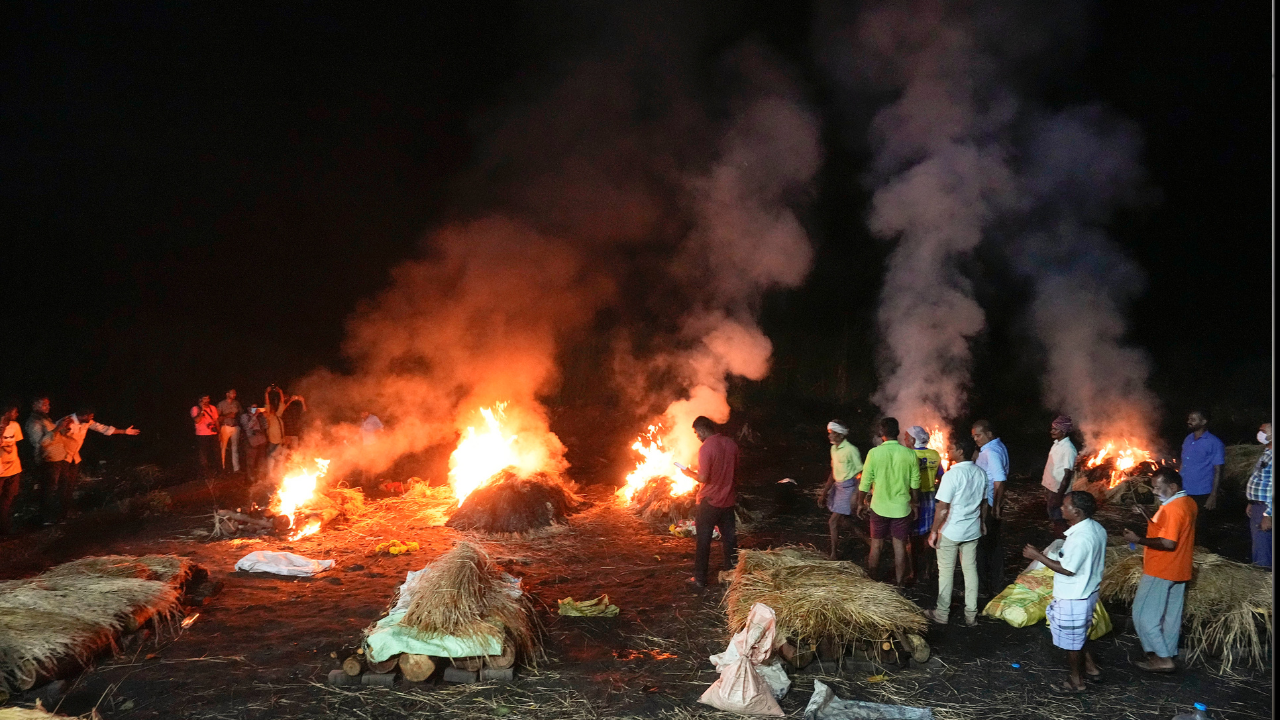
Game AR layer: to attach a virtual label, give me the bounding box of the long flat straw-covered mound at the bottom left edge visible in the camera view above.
[0,555,192,692]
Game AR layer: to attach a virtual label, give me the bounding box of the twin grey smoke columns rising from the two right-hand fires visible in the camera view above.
[824,0,1157,447]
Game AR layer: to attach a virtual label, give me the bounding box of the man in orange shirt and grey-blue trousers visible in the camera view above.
[1124,468,1199,673]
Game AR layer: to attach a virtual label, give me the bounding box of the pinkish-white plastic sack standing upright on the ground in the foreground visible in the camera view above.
[698,602,782,717]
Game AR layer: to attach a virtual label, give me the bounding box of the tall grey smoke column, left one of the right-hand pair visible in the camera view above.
[835,1,1016,427]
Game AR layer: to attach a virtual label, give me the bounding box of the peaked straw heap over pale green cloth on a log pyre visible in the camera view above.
[401,542,538,660]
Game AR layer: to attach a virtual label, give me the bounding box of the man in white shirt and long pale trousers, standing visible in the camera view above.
[924,437,987,628]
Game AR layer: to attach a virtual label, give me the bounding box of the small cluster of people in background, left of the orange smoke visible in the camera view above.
[191,384,307,480]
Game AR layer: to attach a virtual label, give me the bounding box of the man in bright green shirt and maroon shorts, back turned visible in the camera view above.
[854,418,920,587]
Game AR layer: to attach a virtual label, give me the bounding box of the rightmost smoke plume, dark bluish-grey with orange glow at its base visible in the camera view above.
[1011,106,1160,450]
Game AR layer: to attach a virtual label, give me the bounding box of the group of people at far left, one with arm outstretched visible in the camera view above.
[0,397,138,536]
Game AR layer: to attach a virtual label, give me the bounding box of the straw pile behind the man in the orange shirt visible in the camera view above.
[1100,544,1272,673]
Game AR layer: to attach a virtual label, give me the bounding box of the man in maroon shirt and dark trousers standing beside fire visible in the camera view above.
[686,415,737,588]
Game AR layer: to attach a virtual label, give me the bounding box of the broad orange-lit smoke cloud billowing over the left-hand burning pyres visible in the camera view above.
[296,22,820,481]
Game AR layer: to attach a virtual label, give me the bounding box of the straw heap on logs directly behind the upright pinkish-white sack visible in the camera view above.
[724,547,928,647]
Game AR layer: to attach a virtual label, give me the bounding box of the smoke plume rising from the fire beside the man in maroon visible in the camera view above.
[663,53,822,461]
